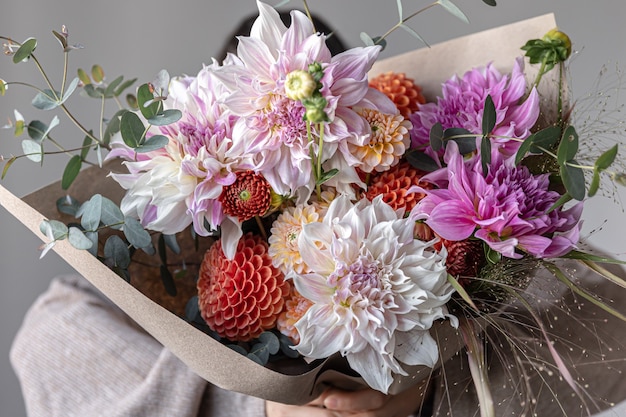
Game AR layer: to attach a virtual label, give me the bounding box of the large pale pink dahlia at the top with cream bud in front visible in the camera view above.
[216,2,397,201]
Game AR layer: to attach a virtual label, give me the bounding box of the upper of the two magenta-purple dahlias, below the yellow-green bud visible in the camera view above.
[411,58,539,160]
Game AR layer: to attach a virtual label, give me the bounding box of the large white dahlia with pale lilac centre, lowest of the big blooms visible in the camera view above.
[294,196,453,393]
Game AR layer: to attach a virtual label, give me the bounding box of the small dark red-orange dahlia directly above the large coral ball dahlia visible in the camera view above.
[219,170,272,222]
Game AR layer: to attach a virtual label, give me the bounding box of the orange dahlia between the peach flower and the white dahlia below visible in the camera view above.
[365,161,432,213]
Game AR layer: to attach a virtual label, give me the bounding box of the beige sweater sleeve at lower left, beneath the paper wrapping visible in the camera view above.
[11,276,264,417]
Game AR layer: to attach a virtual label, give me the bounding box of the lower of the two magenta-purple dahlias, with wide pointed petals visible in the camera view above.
[411,142,583,258]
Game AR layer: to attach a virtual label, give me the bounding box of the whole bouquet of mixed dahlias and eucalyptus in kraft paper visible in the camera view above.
[0,0,626,415]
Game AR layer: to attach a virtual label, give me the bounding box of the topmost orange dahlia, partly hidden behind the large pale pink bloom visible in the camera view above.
[370,72,426,118]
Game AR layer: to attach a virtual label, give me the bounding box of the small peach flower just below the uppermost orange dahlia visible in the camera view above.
[349,109,411,172]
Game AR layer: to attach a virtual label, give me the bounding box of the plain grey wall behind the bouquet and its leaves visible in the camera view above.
[0,0,626,417]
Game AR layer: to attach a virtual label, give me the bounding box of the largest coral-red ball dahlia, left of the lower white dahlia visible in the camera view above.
[198,233,290,342]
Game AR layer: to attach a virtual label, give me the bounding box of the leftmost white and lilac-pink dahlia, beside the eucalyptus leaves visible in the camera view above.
[108,64,254,256]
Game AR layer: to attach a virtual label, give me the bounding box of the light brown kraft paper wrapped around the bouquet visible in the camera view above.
[0,14,556,404]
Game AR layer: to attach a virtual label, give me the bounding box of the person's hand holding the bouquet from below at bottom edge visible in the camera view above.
[266,381,427,417]
